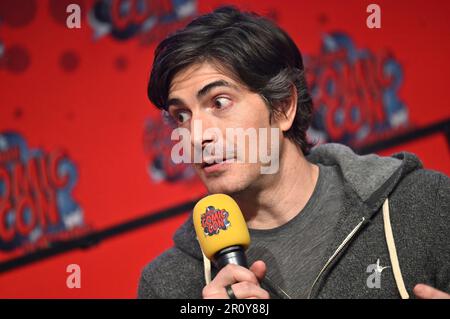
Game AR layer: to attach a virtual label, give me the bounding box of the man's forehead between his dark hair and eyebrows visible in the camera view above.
[169,62,242,98]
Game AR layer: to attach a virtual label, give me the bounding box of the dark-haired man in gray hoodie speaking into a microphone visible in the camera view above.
[138,7,450,298]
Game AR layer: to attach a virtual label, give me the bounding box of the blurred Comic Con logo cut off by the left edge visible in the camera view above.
[0,132,83,251]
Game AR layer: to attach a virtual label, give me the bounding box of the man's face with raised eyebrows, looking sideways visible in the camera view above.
[168,62,279,194]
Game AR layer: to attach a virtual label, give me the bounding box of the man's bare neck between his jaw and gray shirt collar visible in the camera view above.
[233,140,319,229]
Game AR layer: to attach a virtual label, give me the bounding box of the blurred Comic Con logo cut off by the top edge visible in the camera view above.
[88,0,197,43]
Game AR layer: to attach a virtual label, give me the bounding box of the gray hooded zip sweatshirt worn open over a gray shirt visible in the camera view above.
[138,144,450,298]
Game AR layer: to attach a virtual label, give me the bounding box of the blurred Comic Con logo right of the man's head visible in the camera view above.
[305,33,408,145]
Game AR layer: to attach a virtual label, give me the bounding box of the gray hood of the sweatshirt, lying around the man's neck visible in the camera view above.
[173,143,422,260]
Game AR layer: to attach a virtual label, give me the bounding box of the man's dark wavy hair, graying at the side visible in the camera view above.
[148,6,313,155]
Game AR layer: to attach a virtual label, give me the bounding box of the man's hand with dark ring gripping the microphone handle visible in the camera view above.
[202,260,270,299]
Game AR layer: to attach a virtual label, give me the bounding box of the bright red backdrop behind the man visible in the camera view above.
[0,0,450,298]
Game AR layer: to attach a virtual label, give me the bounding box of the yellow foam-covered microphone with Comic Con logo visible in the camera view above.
[192,194,250,269]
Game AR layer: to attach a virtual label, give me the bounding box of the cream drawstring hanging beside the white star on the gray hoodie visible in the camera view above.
[383,198,409,299]
